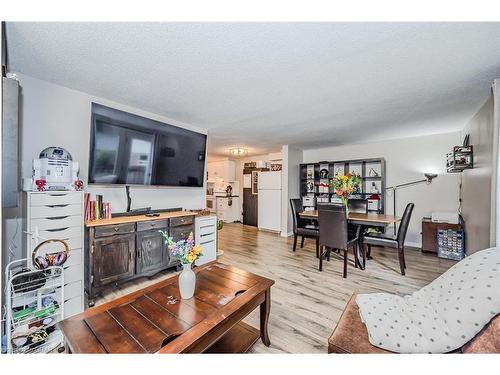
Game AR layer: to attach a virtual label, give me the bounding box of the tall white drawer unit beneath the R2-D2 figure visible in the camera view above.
[23,191,84,318]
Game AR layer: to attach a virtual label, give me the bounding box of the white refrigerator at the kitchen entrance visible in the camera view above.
[257,172,281,232]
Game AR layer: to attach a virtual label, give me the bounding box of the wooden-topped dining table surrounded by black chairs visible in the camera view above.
[299,210,401,269]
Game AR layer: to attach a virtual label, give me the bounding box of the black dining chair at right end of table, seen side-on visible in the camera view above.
[363,203,415,275]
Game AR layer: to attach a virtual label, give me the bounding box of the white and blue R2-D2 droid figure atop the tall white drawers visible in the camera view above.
[24,147,83,191]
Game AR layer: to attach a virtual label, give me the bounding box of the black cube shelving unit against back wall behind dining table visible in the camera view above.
[299,158,386,214]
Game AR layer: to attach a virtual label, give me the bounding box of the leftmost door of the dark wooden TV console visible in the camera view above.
[92,234,135,286]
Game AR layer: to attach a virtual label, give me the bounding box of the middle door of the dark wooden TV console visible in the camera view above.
[136,230,169,275]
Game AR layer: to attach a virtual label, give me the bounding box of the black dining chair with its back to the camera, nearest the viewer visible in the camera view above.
[318,203,361,278]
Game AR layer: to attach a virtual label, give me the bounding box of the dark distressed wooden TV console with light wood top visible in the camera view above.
[85,213,195,306]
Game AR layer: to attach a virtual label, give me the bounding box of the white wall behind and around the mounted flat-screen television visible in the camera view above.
[3,74,206,262]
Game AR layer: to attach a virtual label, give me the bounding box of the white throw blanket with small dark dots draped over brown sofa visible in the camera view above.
[356,247,500,353]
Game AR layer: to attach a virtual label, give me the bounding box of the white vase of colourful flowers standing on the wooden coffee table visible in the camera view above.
[159,230,203,299]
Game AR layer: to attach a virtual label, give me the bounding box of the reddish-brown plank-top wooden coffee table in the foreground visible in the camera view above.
[59,263,274,353]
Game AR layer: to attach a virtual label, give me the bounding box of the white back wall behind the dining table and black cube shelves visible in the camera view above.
[303,132,461,247]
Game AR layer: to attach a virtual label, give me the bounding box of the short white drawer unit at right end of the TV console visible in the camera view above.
[194,215,217,266]
